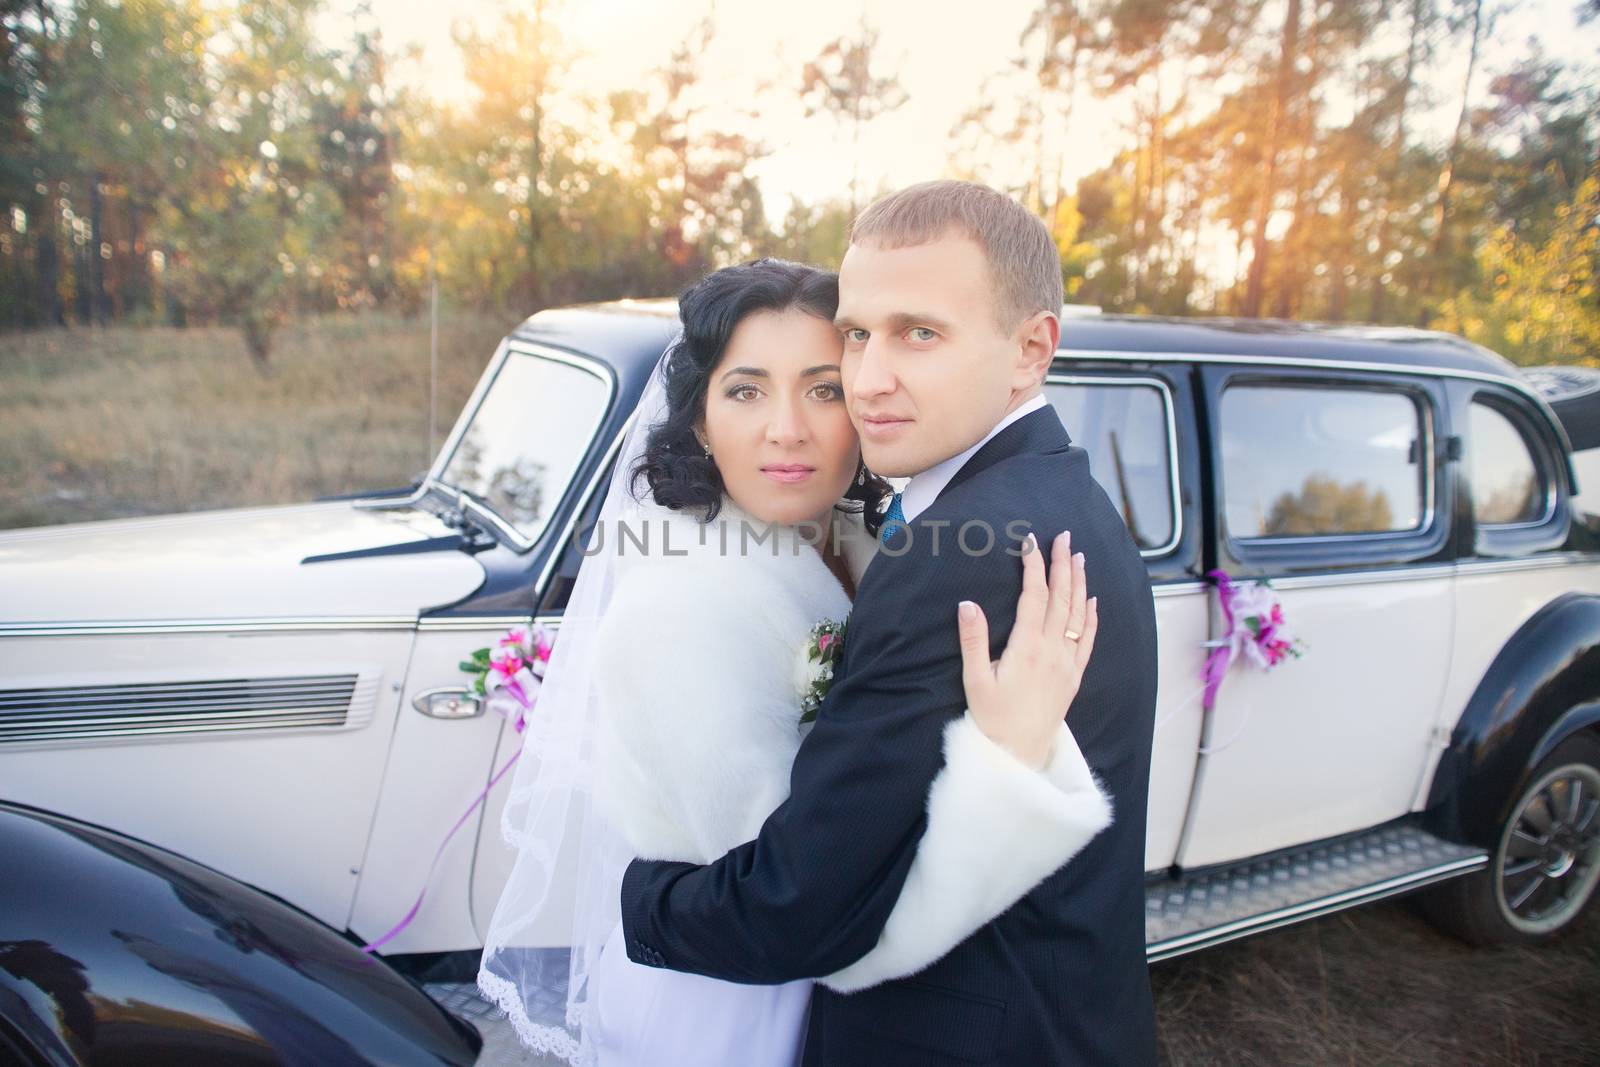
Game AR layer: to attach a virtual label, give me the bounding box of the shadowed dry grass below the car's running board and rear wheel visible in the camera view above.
[1150,901,1600,1067]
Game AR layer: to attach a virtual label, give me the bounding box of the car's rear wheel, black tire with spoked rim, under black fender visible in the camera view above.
[1418,733,1600,945]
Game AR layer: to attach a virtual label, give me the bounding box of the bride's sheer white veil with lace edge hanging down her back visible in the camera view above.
[478,330,683,1064]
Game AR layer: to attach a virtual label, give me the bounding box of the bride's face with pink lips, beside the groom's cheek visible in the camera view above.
[701,309,861,525]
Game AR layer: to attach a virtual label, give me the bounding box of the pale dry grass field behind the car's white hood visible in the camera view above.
[0,315,514,530]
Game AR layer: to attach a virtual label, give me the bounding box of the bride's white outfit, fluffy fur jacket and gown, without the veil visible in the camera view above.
[587,502,1112,1067]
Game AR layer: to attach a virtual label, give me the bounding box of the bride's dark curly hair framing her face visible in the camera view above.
[632,259,891,534]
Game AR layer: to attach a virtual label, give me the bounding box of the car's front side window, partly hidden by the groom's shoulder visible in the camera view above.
[1045,381,1176,553]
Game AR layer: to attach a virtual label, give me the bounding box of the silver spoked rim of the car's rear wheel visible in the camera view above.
[1498,763,1600,933]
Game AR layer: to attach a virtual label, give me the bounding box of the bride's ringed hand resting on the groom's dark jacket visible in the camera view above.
[957,531,1099,768]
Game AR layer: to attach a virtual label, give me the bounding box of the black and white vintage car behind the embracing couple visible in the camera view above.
[0,301,1600,1062]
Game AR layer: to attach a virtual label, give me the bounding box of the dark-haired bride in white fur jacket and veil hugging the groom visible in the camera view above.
[478,259,1112,1067]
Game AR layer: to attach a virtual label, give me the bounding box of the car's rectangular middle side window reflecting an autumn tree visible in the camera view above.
[1219,386,1429,537]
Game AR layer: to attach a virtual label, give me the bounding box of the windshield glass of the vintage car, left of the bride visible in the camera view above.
[438,349,611,544]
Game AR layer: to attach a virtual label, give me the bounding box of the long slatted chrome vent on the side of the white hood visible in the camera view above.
[0,672,366,744]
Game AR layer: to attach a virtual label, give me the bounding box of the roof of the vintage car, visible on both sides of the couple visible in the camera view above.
[512,299,1526,389]
